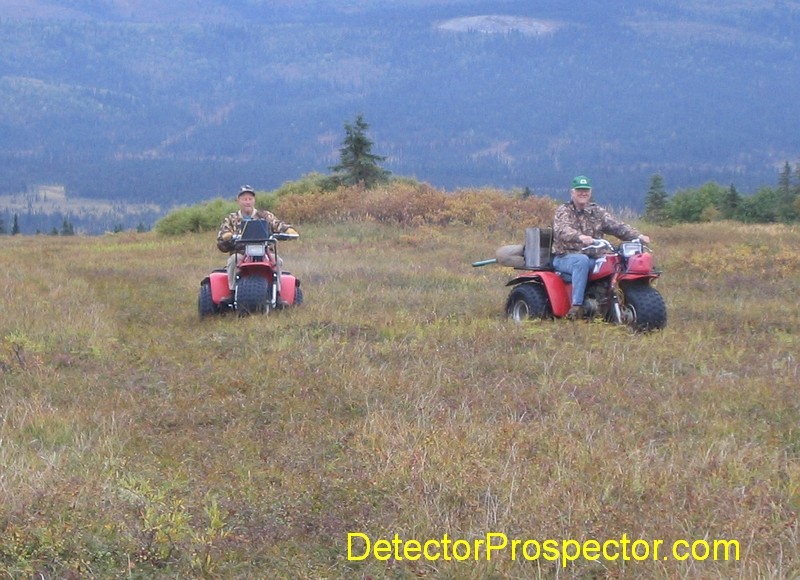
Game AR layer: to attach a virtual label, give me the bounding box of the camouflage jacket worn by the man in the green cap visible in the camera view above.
[553,201,639,256]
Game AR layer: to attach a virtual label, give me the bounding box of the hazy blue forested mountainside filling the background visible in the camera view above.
[0,0,800,231]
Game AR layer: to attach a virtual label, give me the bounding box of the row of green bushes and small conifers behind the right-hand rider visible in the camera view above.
[643,161,800,224]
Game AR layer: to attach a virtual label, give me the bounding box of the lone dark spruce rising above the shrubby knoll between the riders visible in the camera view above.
[330,114,390,189]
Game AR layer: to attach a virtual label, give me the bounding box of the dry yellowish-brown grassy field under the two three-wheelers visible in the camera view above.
[0,223,800,578]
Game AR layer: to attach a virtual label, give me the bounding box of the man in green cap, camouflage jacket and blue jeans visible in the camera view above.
[553,175,650,320]
